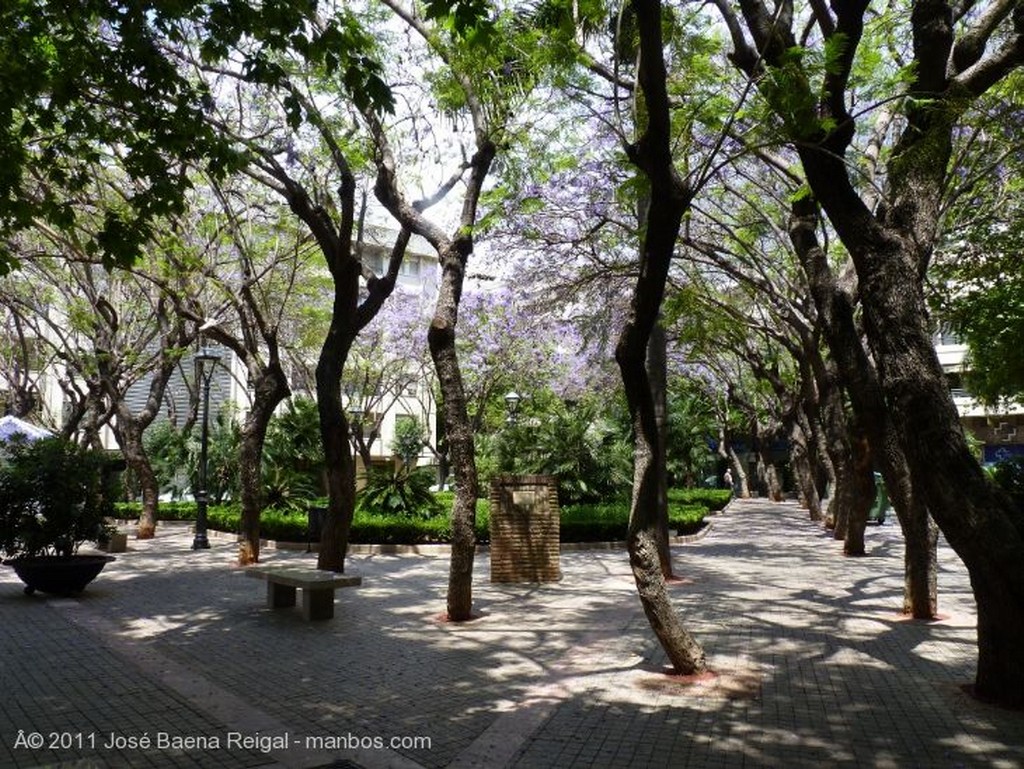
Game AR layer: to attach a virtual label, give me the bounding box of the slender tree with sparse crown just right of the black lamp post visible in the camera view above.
[154,177,312,565]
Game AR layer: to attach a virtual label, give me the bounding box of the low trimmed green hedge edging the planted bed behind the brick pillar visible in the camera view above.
[118,489,712,545]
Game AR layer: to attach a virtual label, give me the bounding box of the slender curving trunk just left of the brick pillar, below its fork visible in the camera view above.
[427,242,477,622]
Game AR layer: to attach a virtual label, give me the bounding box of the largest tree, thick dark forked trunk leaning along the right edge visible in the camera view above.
[716,0,1024,704]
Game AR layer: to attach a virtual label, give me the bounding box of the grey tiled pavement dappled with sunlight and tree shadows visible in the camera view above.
[0,501,1024,769]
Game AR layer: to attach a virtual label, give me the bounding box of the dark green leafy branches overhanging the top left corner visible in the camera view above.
[0,0,394,274]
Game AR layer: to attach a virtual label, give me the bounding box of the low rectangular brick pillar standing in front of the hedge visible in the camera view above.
[490,475,562,583]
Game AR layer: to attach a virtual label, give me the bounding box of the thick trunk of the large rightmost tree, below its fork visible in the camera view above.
[864,264,1024,707]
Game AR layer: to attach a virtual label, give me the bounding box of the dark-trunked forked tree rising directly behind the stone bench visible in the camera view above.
[172,3,419,571]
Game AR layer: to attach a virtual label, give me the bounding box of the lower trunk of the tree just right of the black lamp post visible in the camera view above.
[239,361,291,566]
